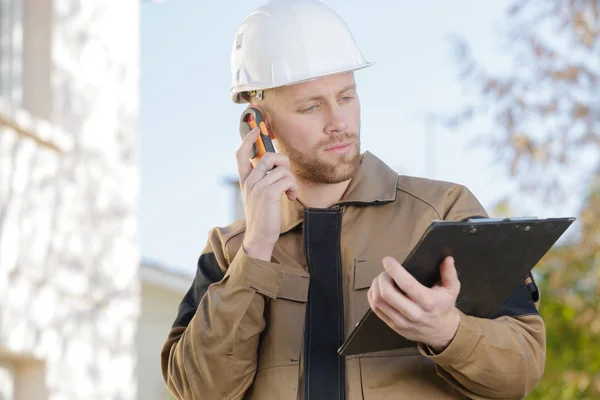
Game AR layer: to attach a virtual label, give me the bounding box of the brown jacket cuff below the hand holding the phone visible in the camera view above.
[225,246,285,299]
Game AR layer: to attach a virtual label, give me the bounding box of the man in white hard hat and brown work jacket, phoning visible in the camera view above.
[161,0,545,400]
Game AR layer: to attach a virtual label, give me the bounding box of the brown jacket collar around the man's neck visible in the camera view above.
[281,151,398,234]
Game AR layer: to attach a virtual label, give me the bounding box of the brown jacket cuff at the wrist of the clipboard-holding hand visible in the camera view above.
[419,310,481,365]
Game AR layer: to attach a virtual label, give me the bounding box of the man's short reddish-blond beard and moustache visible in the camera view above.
[277,132,360,184]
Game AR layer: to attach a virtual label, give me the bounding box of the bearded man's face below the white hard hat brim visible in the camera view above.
[265,72,360,184]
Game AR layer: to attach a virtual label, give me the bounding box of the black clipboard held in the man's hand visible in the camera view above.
[338,217,575,356]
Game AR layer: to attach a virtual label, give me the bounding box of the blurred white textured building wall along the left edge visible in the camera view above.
[0,0,141,400]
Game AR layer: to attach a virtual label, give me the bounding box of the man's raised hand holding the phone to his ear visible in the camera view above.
[236,128,298,262]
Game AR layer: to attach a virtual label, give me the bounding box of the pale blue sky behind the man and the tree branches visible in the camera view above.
[140,0,580,272]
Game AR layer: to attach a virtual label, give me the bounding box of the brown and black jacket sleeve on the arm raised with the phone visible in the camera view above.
[161,230,283,400]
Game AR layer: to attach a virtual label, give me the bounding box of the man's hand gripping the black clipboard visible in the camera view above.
[368,257,460,353]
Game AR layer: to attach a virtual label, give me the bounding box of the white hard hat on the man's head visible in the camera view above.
[230,0,372,103]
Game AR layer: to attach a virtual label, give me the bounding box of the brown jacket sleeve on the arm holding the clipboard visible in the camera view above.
[419,186,546,399]
